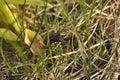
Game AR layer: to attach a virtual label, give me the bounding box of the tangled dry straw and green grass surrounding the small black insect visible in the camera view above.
[0,0,120,80]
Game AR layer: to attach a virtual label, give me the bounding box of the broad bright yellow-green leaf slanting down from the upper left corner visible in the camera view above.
[0,0,21,34]
